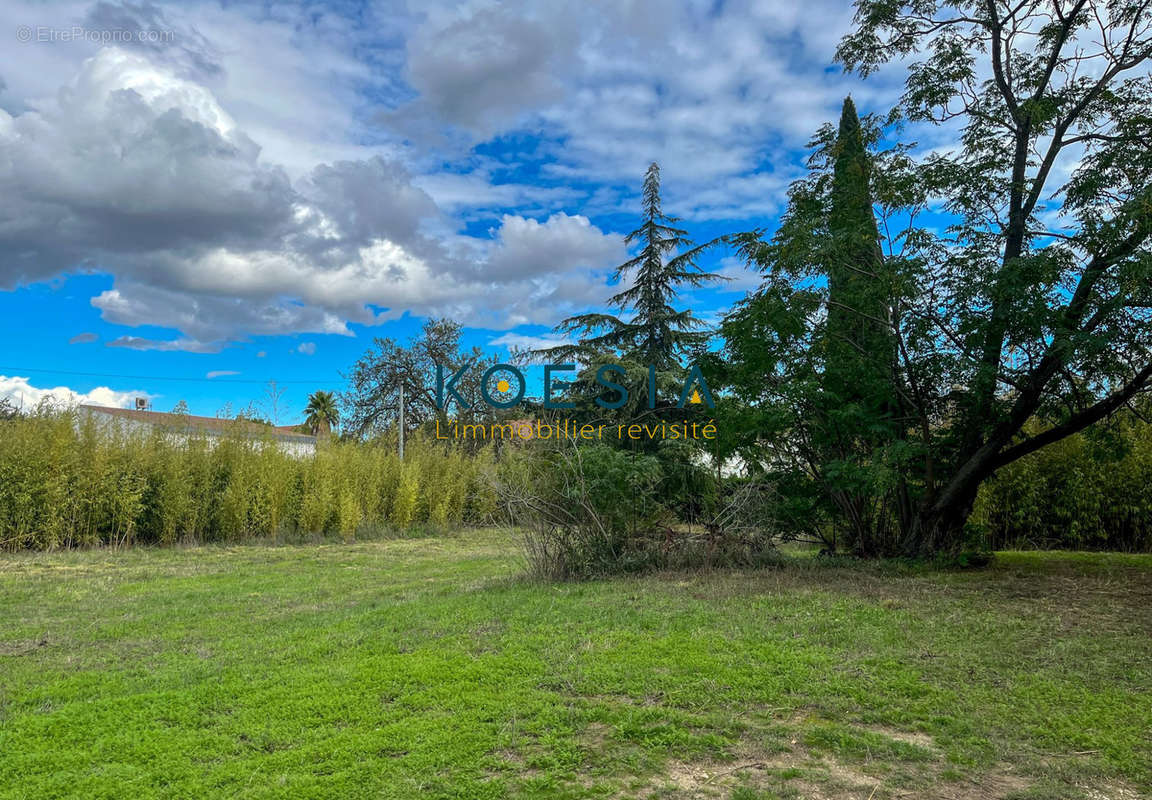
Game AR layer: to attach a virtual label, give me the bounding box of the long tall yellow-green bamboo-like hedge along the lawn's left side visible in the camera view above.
[0,409,494,550]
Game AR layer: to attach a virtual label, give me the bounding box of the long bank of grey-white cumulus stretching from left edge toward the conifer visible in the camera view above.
[0,47,623,341]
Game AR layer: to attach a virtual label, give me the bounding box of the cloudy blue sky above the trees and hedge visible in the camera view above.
[0,0,900,424]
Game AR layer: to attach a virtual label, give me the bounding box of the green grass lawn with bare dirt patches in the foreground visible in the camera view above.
[0,531,1152,800]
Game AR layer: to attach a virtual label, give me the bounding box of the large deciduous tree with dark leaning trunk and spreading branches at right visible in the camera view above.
[728,0,1152,554]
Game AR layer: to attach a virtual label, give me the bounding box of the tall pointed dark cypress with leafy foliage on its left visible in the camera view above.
[706,99,922,556]
